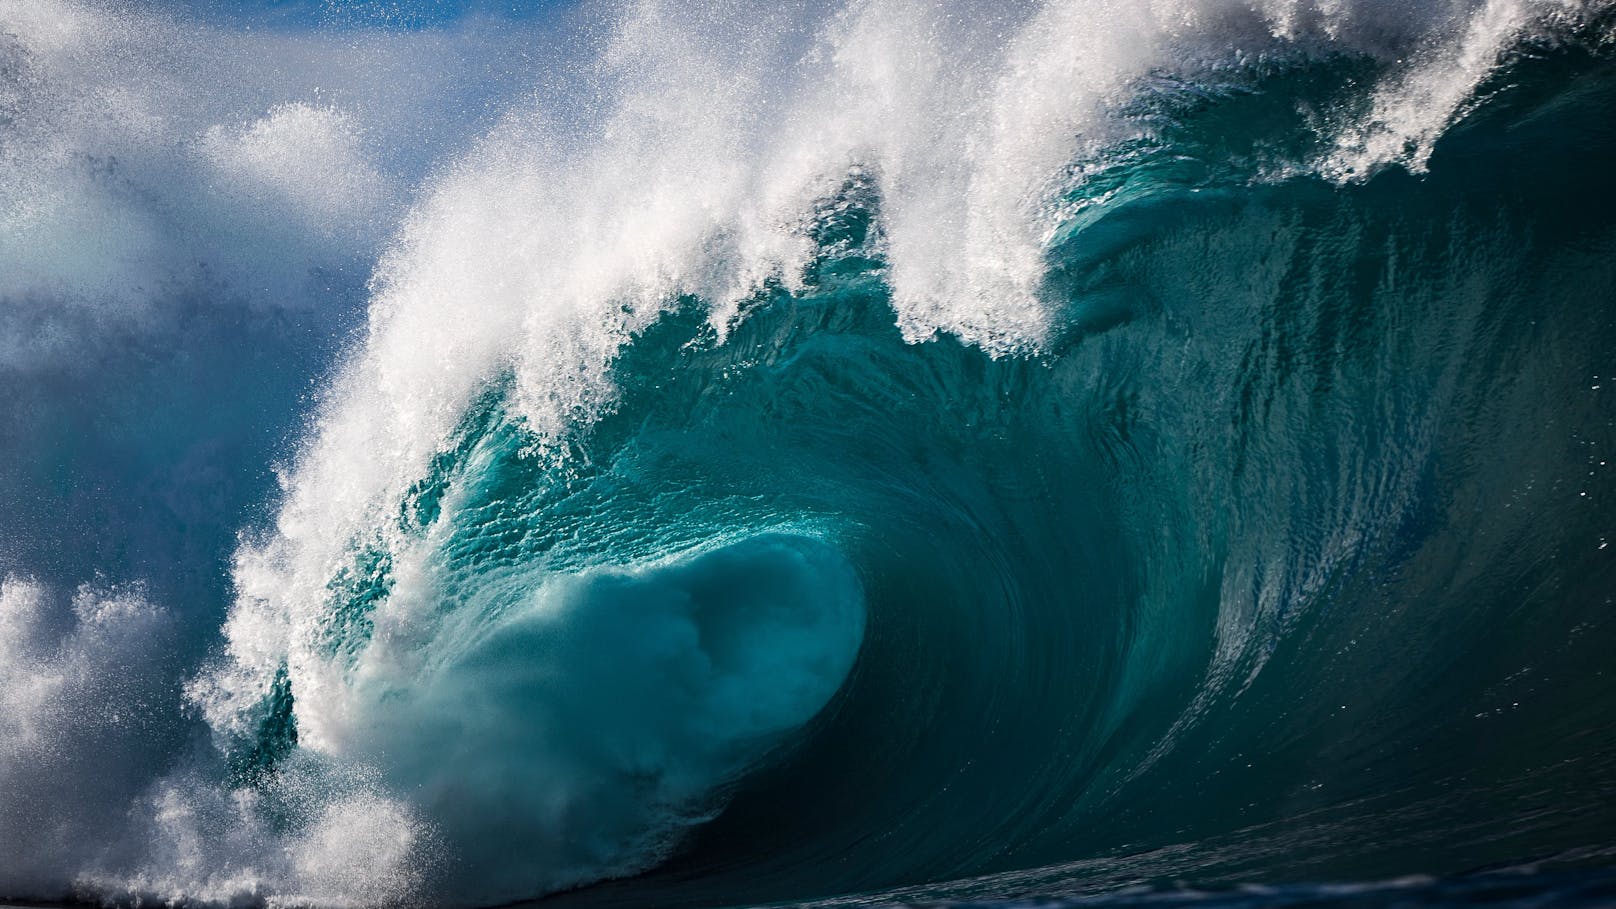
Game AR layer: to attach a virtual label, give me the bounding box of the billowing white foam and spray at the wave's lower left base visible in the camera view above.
[0,576,431,906]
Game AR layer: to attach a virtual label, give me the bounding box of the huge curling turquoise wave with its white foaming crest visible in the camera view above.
[0,5,1616,906]
